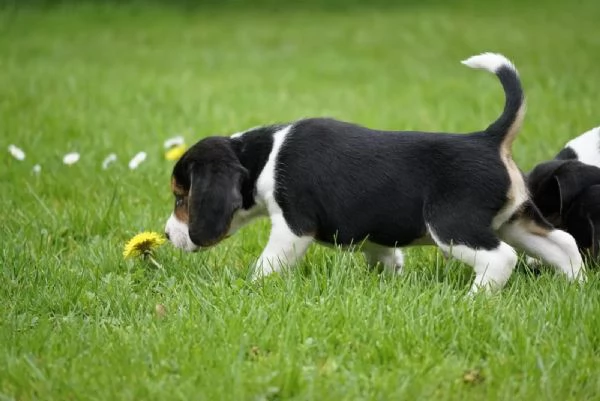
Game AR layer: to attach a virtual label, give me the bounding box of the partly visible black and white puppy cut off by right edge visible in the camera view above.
[527,128,600,261]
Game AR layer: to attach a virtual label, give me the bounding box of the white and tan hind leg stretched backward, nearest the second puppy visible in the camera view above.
[498,202,585,281]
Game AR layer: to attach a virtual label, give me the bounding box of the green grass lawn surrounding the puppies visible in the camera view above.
[0,0,600,401]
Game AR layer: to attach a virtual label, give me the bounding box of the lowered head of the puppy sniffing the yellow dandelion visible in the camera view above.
[165,137,246,252]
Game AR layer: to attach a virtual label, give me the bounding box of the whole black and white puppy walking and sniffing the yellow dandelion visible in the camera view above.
[166,53,583,291]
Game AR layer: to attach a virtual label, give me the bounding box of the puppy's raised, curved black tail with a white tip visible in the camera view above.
[462,53,526,149]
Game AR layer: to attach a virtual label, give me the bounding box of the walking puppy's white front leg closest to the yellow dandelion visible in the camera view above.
[253,214,313,280]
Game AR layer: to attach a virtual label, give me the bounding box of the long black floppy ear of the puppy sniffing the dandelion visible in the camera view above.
[188,161,247,247]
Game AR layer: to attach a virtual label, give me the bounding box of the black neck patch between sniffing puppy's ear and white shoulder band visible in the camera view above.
[231,125,281,210]
